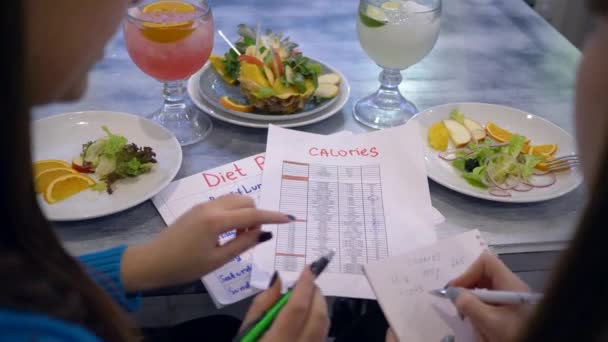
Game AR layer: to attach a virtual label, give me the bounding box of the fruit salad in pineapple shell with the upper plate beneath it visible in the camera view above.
[198,22,344,122]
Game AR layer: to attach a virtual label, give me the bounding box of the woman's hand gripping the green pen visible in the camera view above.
[241,267,329,342]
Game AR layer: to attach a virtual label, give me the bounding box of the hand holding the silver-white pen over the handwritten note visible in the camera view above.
[449,252,532,342]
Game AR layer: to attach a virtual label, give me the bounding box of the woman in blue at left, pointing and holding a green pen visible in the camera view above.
[0,0,328,341]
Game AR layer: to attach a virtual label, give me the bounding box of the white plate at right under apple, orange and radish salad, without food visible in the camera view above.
[411,103,582,203]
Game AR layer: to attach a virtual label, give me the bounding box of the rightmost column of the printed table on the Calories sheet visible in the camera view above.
[361,165,388,261]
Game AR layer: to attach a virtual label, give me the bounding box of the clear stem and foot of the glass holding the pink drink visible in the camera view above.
[150,80,213,146]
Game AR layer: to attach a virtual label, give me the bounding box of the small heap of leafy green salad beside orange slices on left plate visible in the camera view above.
[72,126,157,194]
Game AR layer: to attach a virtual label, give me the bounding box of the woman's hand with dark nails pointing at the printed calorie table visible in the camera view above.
[121,195,290,292]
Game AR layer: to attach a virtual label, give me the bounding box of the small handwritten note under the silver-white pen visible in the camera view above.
[364,230,487,342]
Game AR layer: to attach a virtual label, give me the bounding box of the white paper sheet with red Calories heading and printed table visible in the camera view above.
[251,123,437,298]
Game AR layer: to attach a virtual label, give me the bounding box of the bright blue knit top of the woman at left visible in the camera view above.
[0,245,141,342]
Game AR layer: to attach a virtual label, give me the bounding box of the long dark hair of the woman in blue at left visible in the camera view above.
[0,1,135,341]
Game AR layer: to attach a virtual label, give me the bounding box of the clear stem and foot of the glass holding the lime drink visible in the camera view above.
[354,69,418,129]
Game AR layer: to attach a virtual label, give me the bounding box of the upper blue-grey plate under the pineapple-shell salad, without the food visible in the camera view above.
[198,59,338,122]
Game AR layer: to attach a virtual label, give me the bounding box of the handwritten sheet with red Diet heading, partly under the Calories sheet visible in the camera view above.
[152,154,265,306]
